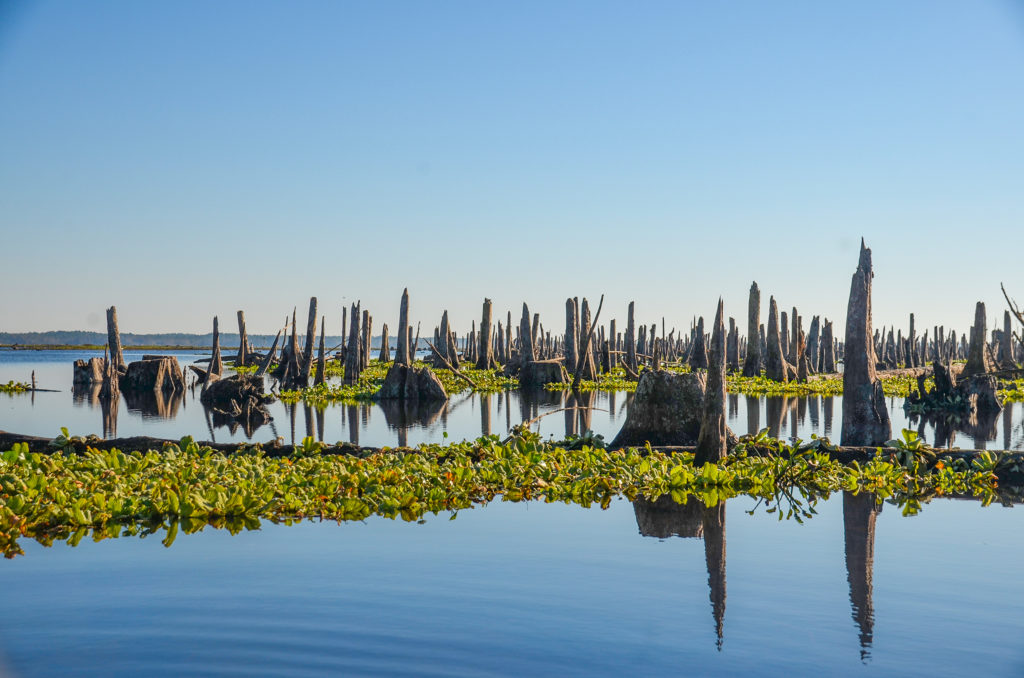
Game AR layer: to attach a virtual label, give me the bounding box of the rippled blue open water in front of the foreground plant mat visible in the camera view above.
[0,495,1024,678]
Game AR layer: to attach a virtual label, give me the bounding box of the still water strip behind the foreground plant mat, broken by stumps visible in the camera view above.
[0,350,1024,450]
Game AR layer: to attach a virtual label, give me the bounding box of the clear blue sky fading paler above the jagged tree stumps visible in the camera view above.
[0,0,1024,336]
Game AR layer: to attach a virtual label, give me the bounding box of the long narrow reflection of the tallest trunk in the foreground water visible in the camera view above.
[843,492,882,660]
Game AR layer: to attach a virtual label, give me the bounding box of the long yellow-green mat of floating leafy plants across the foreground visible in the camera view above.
[0,431,1007,557]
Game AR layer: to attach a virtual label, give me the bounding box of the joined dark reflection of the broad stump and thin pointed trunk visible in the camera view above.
[633,495,725,650]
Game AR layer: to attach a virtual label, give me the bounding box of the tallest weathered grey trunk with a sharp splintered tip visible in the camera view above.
[841,240,892,446]
